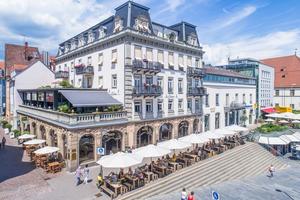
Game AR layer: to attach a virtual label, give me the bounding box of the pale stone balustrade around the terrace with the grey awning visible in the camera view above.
[18,105,127,125]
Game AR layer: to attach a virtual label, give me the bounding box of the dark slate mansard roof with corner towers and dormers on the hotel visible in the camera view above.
[59,1,199,54]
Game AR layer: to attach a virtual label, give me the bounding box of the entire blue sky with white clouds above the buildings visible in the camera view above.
[0,0,300,64]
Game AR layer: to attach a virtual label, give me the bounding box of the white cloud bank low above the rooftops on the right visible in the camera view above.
[203,29,300,65]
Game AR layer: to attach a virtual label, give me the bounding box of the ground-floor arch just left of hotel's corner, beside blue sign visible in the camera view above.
[102,131,122,155]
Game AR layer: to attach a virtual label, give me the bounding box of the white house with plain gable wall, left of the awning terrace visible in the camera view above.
[7,61,55,128]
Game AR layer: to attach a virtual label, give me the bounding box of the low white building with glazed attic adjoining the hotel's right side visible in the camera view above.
[203,67,256,131]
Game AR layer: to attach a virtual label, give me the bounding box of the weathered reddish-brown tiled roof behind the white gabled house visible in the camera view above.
[5,44,41,74]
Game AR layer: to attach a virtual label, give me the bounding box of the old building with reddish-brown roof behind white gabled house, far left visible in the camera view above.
[4,42,41,120]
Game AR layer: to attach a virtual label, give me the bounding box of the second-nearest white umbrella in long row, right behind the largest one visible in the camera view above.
[133,144,171,158]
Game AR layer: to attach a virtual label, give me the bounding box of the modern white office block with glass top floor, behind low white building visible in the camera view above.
[218,58,275,117]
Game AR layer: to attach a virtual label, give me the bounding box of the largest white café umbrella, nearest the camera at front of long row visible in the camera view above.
[97,152,143,169]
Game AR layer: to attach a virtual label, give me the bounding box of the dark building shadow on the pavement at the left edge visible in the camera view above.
[0,145,35,183]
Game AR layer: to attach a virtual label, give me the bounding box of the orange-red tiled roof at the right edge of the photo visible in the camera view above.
[261,55,300,88]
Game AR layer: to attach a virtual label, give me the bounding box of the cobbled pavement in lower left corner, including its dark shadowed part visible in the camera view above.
[0,128,108,200]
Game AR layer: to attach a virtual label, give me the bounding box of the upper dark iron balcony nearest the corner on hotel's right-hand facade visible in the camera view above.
[132,59,163,74]
